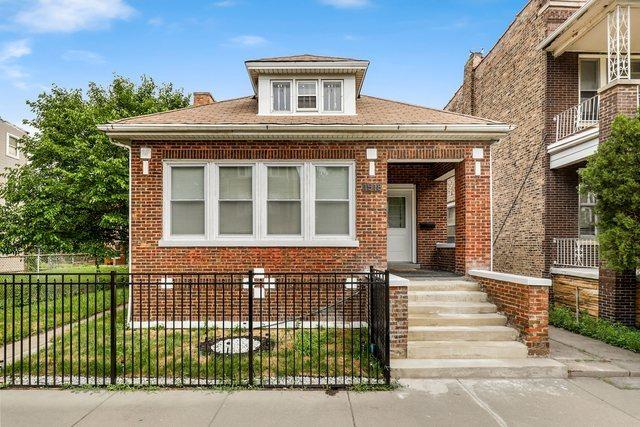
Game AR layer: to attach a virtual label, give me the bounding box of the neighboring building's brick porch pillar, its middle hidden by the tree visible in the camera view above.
[598,79,638,326]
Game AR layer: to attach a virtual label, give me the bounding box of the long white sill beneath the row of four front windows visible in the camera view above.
[158,239,360,248]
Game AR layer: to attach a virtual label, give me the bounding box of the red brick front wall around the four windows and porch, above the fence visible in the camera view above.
[131,141,489,272]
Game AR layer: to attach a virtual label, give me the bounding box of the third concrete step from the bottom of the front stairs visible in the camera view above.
[409,326,518,341]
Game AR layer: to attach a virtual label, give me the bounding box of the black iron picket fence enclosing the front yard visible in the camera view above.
[0,268,390,387]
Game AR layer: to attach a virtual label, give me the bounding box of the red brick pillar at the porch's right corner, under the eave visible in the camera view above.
[455,148,491,274]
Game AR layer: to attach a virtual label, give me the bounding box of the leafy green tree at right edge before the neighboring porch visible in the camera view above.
[580,116,640,271]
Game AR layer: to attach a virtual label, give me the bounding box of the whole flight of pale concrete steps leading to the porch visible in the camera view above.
[391,279,567,379]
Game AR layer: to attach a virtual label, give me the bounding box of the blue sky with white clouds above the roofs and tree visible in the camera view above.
[0,0,525,130]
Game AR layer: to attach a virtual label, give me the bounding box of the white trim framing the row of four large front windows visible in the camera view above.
[158,160,360,247]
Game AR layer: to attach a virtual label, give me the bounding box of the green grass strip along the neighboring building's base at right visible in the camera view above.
[549,306,640,353]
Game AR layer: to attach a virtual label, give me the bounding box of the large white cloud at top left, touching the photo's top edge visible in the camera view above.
[16,0,134,33]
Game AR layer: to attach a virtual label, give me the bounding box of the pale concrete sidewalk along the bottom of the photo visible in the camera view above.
[0,378,640,427]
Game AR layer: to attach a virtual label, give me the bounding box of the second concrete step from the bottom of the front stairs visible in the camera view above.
[407,340,528,359]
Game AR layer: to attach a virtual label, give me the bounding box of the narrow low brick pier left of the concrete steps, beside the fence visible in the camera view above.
[389,284,409,359]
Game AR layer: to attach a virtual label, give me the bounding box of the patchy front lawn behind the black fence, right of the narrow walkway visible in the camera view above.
[7,309,384,386]
